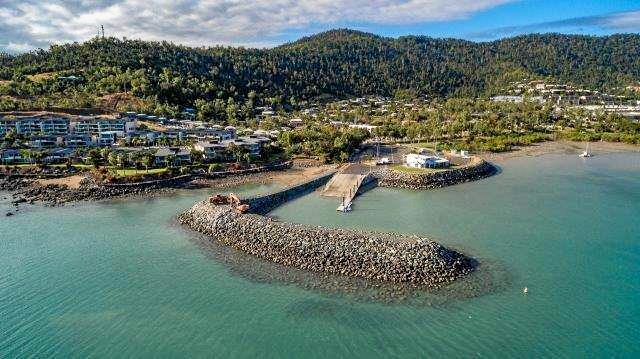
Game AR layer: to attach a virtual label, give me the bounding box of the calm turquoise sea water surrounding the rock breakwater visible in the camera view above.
[0,153,640,358]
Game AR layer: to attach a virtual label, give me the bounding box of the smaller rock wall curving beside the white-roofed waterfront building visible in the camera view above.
[373,157,497,189]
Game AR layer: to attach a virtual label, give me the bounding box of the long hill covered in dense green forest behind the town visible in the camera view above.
[0,30,640,111]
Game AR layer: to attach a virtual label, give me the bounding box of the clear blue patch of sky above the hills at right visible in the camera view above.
[285,0,640,41]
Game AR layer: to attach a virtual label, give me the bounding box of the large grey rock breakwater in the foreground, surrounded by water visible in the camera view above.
[178,201,476,288]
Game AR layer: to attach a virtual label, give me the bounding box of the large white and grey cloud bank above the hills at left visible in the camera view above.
[0,0,514,51]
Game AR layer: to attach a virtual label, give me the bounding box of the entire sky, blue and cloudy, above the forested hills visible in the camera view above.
[0,0,640,53]
